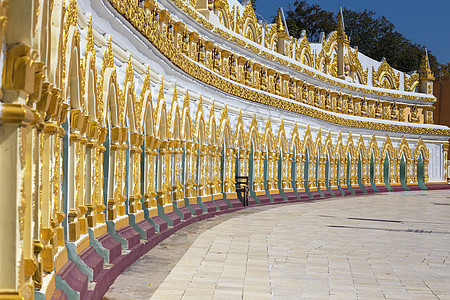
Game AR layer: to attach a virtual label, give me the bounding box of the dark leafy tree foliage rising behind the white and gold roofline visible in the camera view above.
[286,0,442,74]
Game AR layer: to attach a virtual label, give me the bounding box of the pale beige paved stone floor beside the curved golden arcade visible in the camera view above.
[106,191,450,299]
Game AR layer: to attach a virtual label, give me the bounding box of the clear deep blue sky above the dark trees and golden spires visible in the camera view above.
[256,0,450,64]
